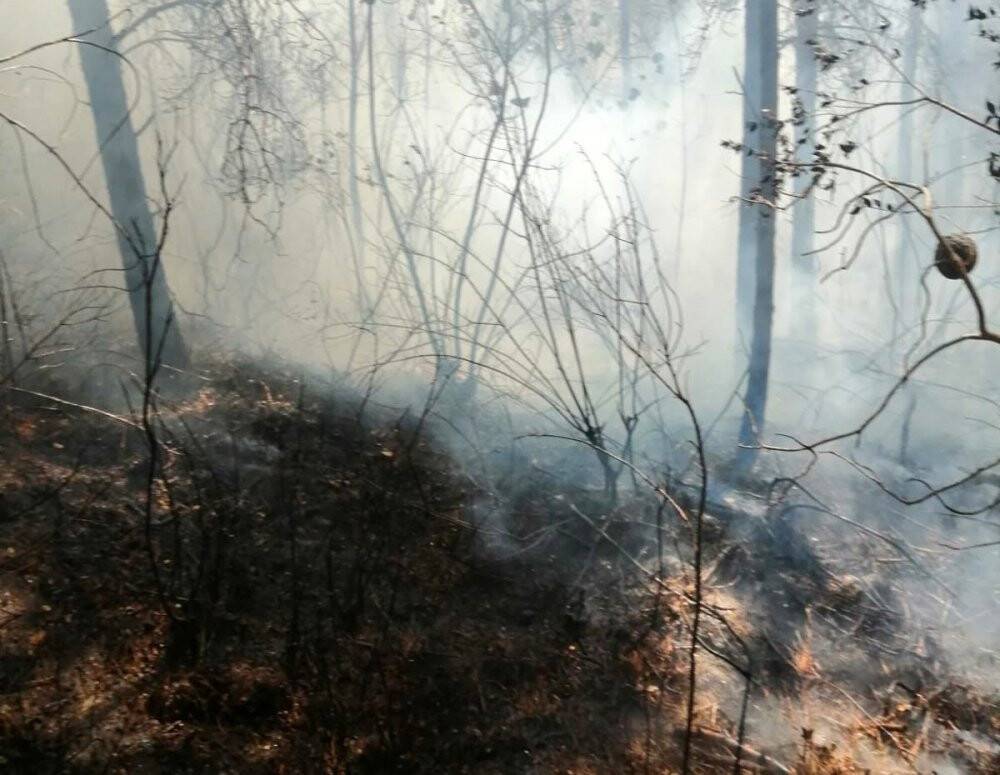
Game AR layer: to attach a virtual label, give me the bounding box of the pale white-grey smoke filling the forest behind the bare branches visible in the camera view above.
[0,0,1000,771]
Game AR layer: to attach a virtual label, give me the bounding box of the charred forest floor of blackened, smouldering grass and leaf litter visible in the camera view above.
[0,361,1000,775]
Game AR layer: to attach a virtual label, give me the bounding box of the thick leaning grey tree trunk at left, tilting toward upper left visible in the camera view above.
[68,0,188,368]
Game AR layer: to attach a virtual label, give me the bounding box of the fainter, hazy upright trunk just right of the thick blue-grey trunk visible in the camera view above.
[792,0,819,343]
